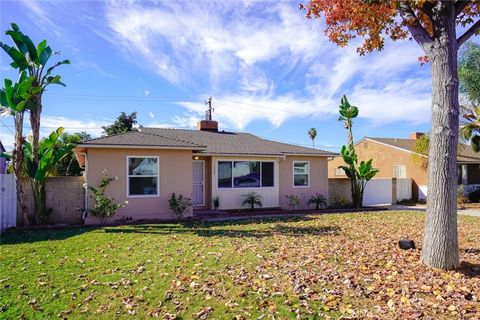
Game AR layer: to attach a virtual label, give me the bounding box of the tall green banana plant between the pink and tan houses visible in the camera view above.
[338,95,378,208]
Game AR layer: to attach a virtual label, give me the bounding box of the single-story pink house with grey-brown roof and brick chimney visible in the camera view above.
[75,120,335,219]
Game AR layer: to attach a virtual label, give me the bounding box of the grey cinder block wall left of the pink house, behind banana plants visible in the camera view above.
[17,176,85,224]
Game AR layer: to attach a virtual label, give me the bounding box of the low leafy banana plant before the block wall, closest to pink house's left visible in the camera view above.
[23,127,75,224]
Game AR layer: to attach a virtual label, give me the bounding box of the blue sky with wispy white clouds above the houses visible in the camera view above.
[0,0,431,151]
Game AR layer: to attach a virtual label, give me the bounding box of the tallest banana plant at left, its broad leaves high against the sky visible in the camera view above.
[0,23,70,165]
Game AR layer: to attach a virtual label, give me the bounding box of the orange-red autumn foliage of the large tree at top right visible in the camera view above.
[300,0,480,55]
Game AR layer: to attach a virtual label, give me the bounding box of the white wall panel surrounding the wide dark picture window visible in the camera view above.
[211,157,281,210]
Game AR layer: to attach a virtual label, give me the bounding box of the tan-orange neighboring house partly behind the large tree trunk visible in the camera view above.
[328,132,480,200]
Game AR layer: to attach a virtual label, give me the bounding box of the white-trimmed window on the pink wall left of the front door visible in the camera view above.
[127,156,160,197]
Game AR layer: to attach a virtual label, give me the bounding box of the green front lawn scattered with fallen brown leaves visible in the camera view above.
[0,212,480,319]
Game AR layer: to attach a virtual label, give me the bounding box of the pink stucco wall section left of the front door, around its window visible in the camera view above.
[85,148,192,224]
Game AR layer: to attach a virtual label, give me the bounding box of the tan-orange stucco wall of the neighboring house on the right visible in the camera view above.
[328,140,428,199]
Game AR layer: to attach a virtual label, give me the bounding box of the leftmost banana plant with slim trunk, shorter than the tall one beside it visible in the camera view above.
[0,71,38,224]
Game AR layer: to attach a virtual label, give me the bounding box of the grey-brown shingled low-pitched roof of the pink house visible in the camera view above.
[79,128,336,156]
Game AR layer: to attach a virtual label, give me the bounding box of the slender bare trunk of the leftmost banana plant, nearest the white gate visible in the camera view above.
[12,113,31,225]
